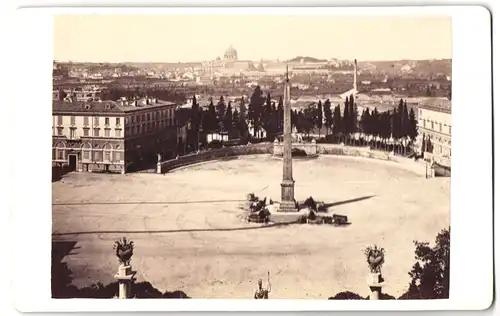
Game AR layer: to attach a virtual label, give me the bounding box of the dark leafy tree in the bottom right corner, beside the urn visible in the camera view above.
[400,228,450,299]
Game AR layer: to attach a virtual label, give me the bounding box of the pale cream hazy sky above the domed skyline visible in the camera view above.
[54,14,452,62]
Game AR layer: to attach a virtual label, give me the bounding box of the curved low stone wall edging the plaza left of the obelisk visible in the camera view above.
[156,143,273,173]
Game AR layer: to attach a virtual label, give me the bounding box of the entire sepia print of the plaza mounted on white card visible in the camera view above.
[51,14,453,300]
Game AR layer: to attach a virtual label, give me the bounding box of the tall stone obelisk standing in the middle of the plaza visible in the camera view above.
[278,65,297,212]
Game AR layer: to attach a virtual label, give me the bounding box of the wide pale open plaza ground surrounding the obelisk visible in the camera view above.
[52,156,450,299]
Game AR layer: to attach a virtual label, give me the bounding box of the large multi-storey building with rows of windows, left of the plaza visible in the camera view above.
[52,98,178,173]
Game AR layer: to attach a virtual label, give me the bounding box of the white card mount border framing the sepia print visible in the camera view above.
[6,6,493,312]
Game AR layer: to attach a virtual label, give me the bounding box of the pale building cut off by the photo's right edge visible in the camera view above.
[417,100,452,167]
